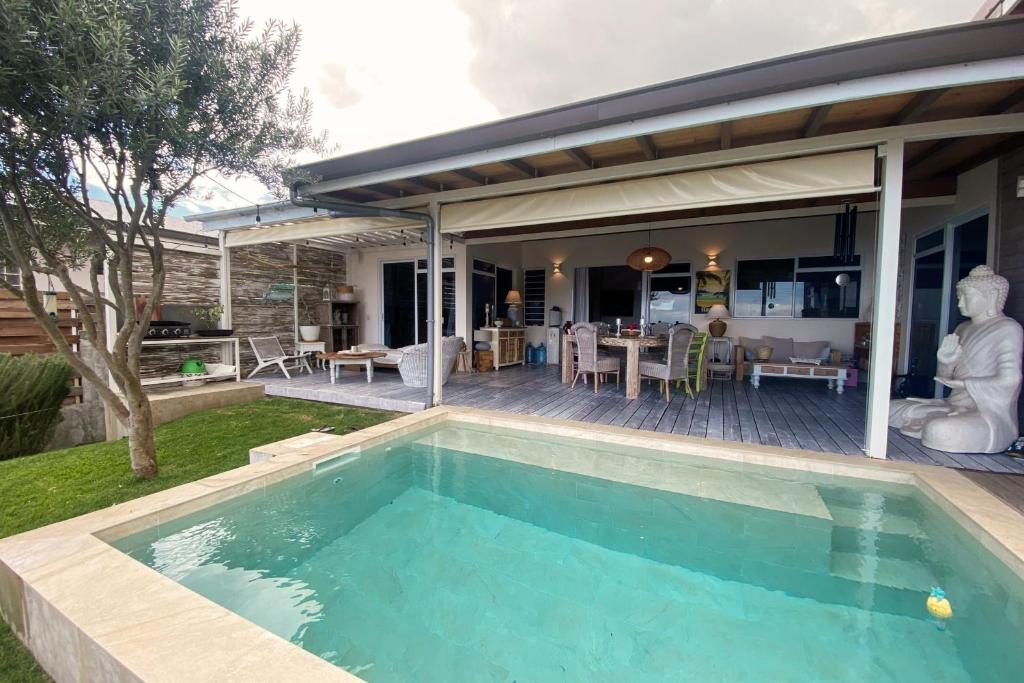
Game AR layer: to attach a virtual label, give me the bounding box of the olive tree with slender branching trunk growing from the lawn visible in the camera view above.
[0,0,324,478]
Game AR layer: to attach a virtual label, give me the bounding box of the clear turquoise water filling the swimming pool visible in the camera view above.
[115,427,1024,682]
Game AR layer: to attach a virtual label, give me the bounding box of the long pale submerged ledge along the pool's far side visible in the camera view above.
[416,427,831,523]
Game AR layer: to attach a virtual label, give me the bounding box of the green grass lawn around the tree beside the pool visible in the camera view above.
[0,398,396,683]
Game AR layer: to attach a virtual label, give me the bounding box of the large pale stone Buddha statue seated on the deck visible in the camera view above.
[889,265,1024,453]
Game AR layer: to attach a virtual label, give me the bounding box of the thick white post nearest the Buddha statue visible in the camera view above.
[864,139,903,458]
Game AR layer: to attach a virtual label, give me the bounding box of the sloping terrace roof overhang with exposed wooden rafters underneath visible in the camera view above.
[191,17,1024,245]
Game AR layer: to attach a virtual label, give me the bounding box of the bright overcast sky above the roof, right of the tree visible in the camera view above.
[175,0,982,214]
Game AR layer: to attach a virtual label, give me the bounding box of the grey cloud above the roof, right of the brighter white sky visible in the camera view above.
[459,0,978,116]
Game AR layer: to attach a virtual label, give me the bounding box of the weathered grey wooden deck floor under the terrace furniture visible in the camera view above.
[257,367,1024,474]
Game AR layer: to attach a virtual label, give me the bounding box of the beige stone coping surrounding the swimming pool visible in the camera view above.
[0,407,1024,683]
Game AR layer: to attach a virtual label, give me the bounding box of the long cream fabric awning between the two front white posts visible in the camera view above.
[440,148,878,232]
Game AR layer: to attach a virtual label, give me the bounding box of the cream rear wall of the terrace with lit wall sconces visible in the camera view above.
[509,212,876,353]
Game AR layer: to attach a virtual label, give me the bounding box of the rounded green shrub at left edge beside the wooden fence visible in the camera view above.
[0,353,75,460]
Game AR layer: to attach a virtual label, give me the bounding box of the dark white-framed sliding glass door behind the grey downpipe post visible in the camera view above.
[381,257,456,348]
